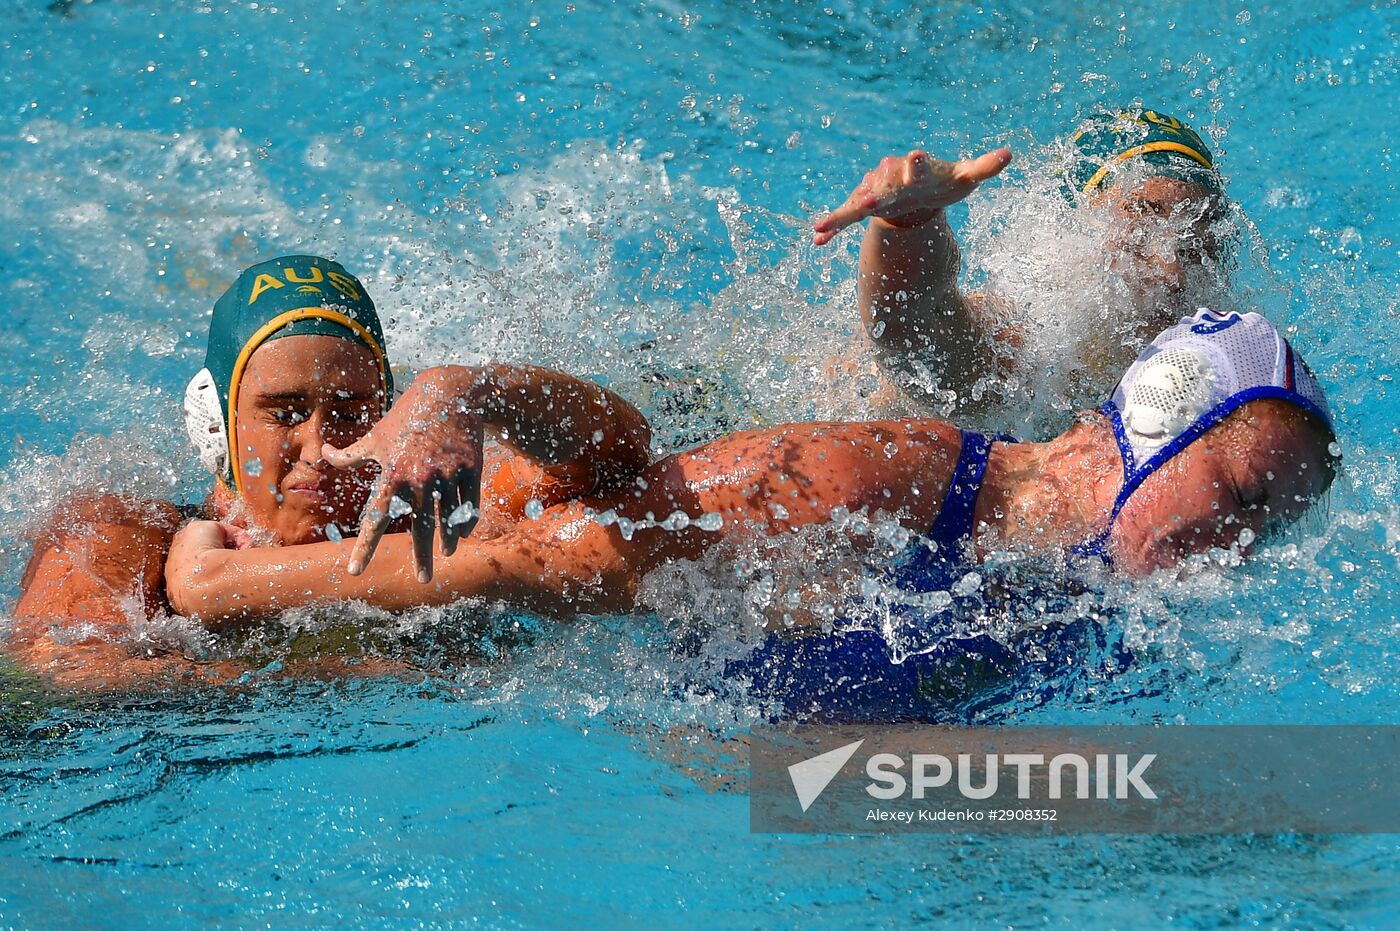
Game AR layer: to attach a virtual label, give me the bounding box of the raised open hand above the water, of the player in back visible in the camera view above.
[812,148,1011,245]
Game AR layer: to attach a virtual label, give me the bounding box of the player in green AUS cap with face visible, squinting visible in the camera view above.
[7,255,650,685]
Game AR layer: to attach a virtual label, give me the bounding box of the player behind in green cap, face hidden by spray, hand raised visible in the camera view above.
[813,109,1225,414]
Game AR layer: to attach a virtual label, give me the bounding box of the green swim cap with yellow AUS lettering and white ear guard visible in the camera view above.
[185,255,393,493]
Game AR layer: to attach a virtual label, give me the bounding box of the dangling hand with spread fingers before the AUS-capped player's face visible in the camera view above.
[322,370,483,582]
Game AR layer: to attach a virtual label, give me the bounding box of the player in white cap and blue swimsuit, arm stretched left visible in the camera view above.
[158,311,1334,714]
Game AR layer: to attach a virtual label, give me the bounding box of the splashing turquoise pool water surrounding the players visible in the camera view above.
[0,0,1400,927]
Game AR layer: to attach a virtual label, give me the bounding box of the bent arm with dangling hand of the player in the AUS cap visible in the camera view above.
[323,364,651,581]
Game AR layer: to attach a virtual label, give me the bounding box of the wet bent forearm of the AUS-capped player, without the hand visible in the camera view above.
[423,364,651,484]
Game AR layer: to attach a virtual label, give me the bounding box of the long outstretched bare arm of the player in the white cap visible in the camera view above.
[167,420,959,627]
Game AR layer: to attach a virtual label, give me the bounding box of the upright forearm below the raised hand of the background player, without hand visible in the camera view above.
[858,210,987,389]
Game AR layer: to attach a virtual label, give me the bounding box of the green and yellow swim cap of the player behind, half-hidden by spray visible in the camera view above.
[1065,108,1221,193]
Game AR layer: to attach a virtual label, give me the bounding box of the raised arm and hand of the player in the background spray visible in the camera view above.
[813,148,1011,406]
